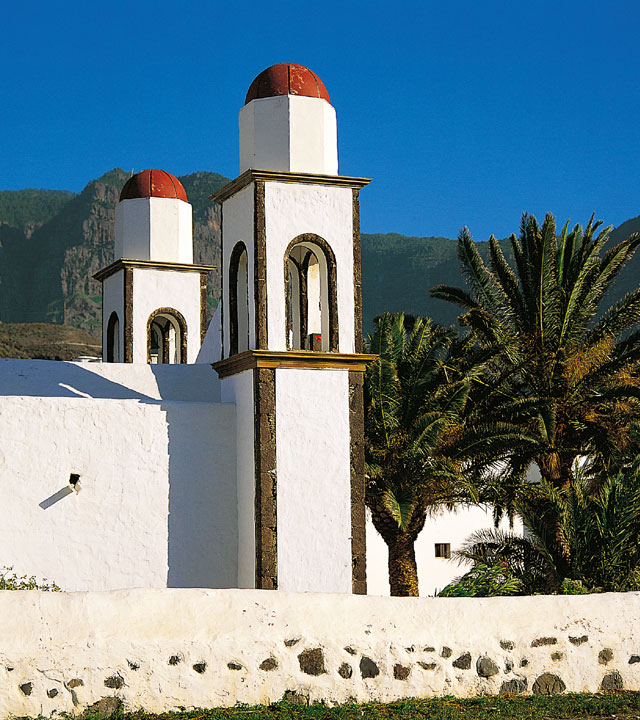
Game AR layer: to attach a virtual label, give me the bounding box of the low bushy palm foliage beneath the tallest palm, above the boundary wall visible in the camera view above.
[452,450,640,595]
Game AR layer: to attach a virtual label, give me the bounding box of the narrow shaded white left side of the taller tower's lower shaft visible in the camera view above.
[221,370,256,588]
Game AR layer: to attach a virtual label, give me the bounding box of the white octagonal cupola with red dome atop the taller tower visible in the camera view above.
[239,63,338,175]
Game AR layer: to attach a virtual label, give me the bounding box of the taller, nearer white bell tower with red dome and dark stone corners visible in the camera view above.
[212,63,371,593]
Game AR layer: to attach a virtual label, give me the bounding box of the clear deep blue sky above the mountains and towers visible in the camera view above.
[0,0,640,240]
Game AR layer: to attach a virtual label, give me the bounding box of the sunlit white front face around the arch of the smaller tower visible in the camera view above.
[133,268,200,363]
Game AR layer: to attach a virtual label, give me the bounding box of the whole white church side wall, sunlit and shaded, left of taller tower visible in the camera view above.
[0,360,237,590]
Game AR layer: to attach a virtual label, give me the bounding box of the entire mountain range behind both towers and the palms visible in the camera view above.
[0,169,640,346]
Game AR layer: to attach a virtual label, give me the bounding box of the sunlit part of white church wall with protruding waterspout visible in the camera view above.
[0,397,169,590]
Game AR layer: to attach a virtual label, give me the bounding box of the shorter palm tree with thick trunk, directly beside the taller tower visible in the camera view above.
[365,314,512,595]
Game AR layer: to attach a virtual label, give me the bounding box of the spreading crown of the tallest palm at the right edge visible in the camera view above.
[431,214,640,506]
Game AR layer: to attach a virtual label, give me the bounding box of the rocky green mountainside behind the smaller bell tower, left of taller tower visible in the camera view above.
[0,169,227,337]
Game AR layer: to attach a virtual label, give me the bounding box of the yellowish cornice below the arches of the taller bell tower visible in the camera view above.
[212,350,378,378]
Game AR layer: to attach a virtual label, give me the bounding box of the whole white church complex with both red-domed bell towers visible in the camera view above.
[0,63,504,595]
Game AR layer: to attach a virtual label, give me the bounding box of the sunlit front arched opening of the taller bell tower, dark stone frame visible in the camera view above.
[284,233,338,352]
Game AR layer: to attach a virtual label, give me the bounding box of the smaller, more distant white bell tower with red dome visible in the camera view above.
[94,170,213,363]
